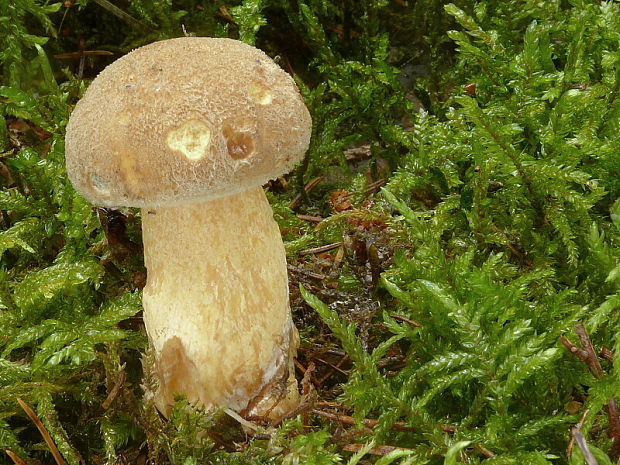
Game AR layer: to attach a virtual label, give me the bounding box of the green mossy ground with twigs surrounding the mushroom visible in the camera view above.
[0,0,620,465]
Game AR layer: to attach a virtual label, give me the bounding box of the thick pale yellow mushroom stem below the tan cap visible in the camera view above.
[142,187,299,418]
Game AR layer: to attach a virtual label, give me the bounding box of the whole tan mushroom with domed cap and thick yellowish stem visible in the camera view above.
[66,37,312,418]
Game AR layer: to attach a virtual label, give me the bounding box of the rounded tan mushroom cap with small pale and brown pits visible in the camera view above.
[65,37,312,207]
